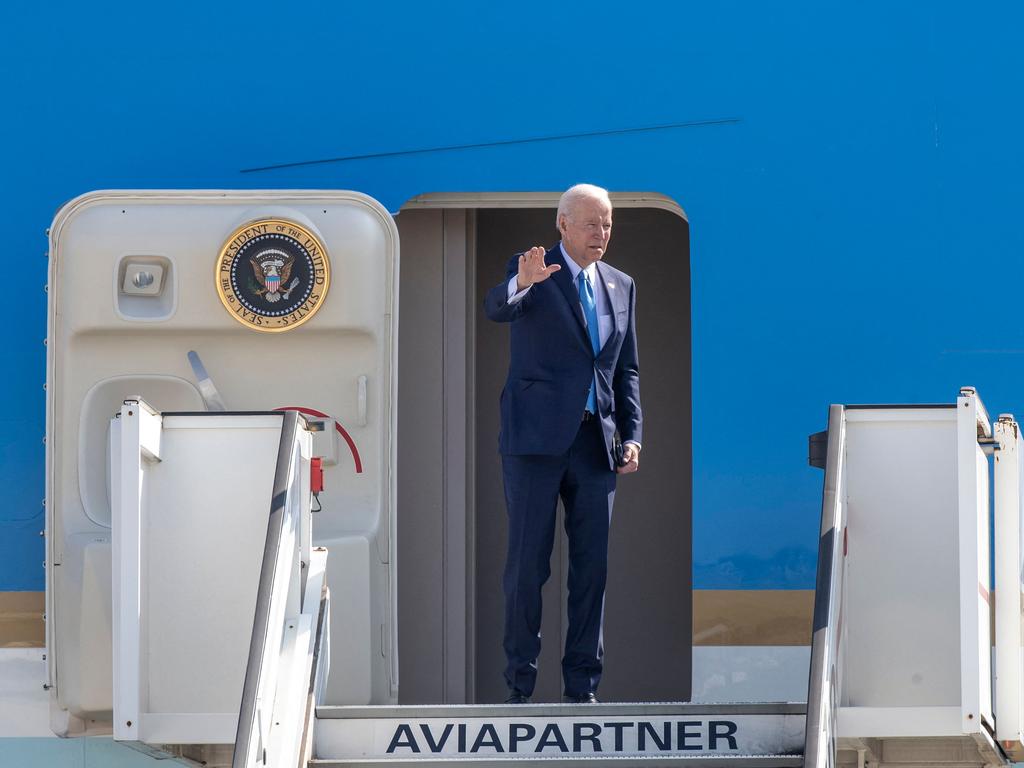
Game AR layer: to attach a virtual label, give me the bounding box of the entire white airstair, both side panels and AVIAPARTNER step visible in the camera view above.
[96,388,1024,768]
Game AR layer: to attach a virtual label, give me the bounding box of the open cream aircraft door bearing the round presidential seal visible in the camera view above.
[46,190,398,733]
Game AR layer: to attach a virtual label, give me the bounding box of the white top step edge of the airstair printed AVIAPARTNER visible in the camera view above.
[310,702,807,768]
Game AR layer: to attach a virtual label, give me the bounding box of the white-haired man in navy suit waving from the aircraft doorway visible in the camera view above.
[483,184,642,703]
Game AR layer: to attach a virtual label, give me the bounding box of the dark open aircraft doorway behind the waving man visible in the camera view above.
[395,194,692,703]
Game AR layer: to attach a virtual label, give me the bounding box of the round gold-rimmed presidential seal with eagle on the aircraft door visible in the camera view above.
[216,219,331,333]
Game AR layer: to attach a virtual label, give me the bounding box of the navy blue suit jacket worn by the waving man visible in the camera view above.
[483,246,643,469]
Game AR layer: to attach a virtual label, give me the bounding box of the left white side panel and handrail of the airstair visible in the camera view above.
[111,397,330,766]
